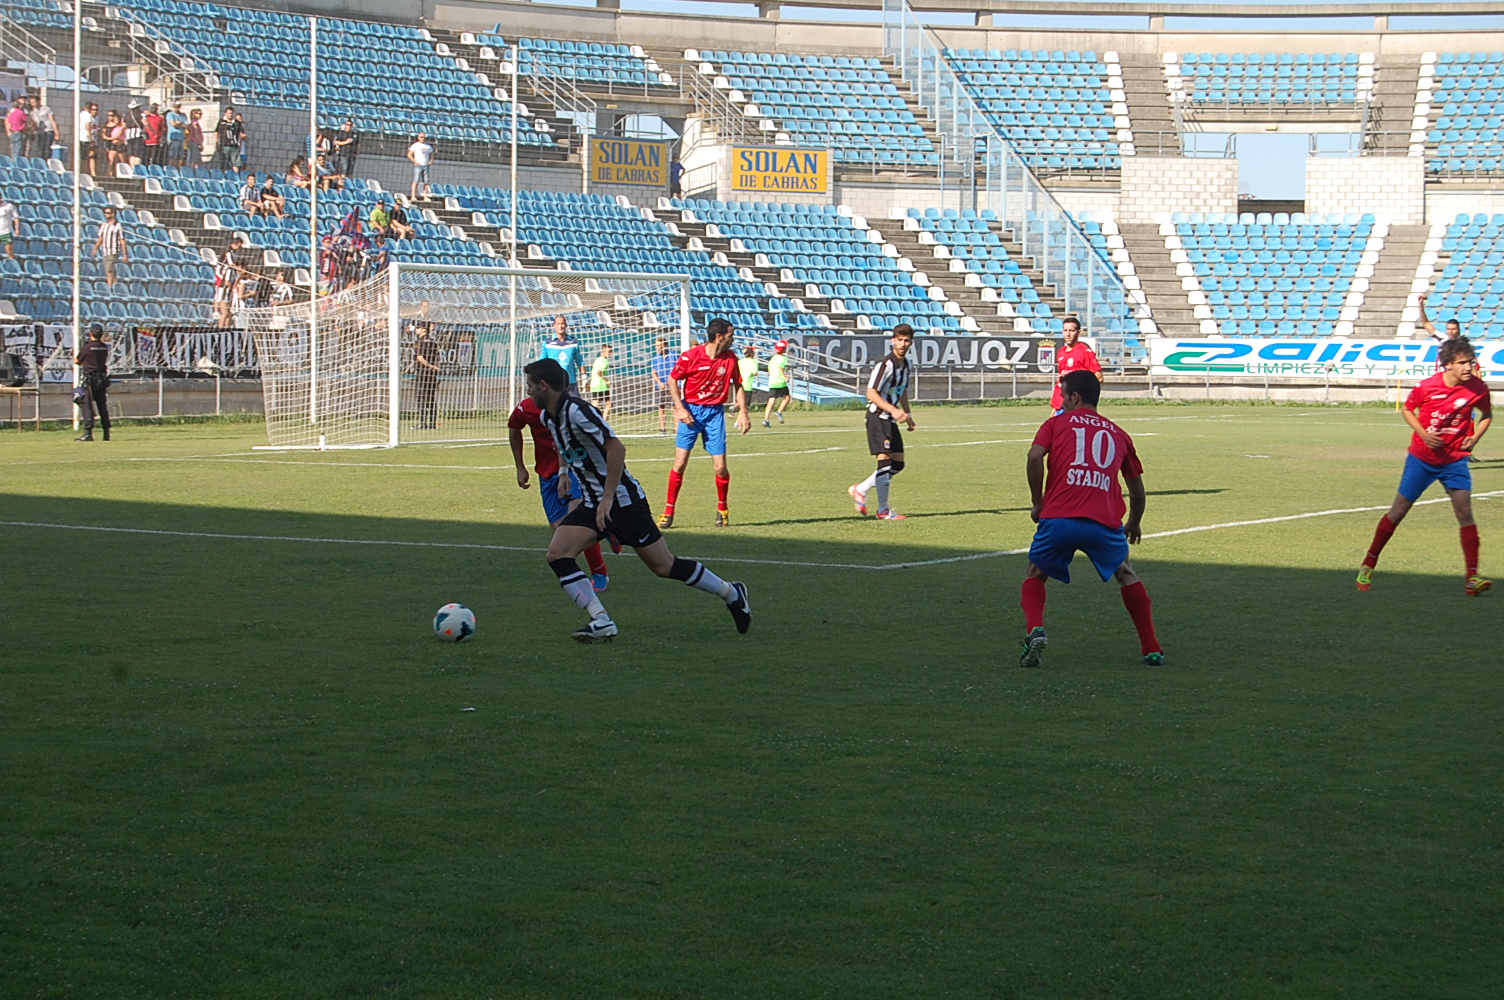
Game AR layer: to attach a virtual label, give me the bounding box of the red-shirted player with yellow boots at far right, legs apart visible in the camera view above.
[1358,337,1493,597]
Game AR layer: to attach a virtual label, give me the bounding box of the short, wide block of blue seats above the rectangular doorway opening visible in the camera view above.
[1164,53,1375,107]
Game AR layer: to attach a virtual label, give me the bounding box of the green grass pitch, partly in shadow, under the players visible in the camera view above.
[0,406,1504,1000]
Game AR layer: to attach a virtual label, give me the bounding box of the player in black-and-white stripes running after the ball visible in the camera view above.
[522,358,752,642]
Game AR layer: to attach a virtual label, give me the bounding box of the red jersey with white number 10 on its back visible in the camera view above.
[1033,409,1143,528]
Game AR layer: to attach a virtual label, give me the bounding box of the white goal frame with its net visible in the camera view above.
[239,263,690,448]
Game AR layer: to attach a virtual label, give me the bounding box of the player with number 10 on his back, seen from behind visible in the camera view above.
[1018,370,1164,666]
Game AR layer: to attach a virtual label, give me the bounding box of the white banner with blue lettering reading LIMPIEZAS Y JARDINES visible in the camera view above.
[1148,337,1504,379]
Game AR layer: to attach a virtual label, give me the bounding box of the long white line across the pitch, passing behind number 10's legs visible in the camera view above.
[0,490,1504,570]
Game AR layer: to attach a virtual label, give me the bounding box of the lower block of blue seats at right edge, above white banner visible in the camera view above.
[1426,214,1504,340]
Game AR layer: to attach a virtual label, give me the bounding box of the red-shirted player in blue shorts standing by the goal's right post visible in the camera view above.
[659,319,752,528]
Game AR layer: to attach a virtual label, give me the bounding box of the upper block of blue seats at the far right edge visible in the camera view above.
[1421,53,1504,173]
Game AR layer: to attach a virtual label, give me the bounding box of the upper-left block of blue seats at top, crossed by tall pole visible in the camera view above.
[106,0,553,146]
